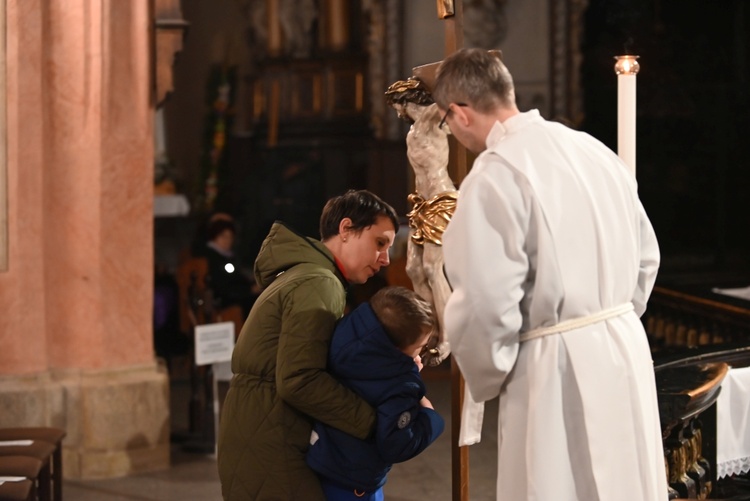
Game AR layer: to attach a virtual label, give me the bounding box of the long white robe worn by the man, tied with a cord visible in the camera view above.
[443,110,667,501]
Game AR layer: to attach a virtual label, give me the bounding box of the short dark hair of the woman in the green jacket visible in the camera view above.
[320,190,398,241]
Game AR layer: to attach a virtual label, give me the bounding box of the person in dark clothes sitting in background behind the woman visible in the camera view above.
[194,214,260,317]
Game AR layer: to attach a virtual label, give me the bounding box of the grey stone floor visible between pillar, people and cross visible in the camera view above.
[64,367,497,501]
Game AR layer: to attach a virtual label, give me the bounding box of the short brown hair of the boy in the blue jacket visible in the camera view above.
[370,285,437,348]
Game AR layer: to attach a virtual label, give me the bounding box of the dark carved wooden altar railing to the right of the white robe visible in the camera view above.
[642,274,750,500]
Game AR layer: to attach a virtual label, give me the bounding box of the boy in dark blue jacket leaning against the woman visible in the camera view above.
[307,287,444,501]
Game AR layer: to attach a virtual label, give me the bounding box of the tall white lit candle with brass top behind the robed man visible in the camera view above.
[615,55,640,175]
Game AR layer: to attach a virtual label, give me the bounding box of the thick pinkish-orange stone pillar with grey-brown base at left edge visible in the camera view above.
[0,0,169,478]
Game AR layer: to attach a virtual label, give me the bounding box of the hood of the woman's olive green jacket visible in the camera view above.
[254,221,349,288]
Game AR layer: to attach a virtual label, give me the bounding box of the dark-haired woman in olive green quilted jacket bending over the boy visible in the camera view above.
[218,190,398,501]
